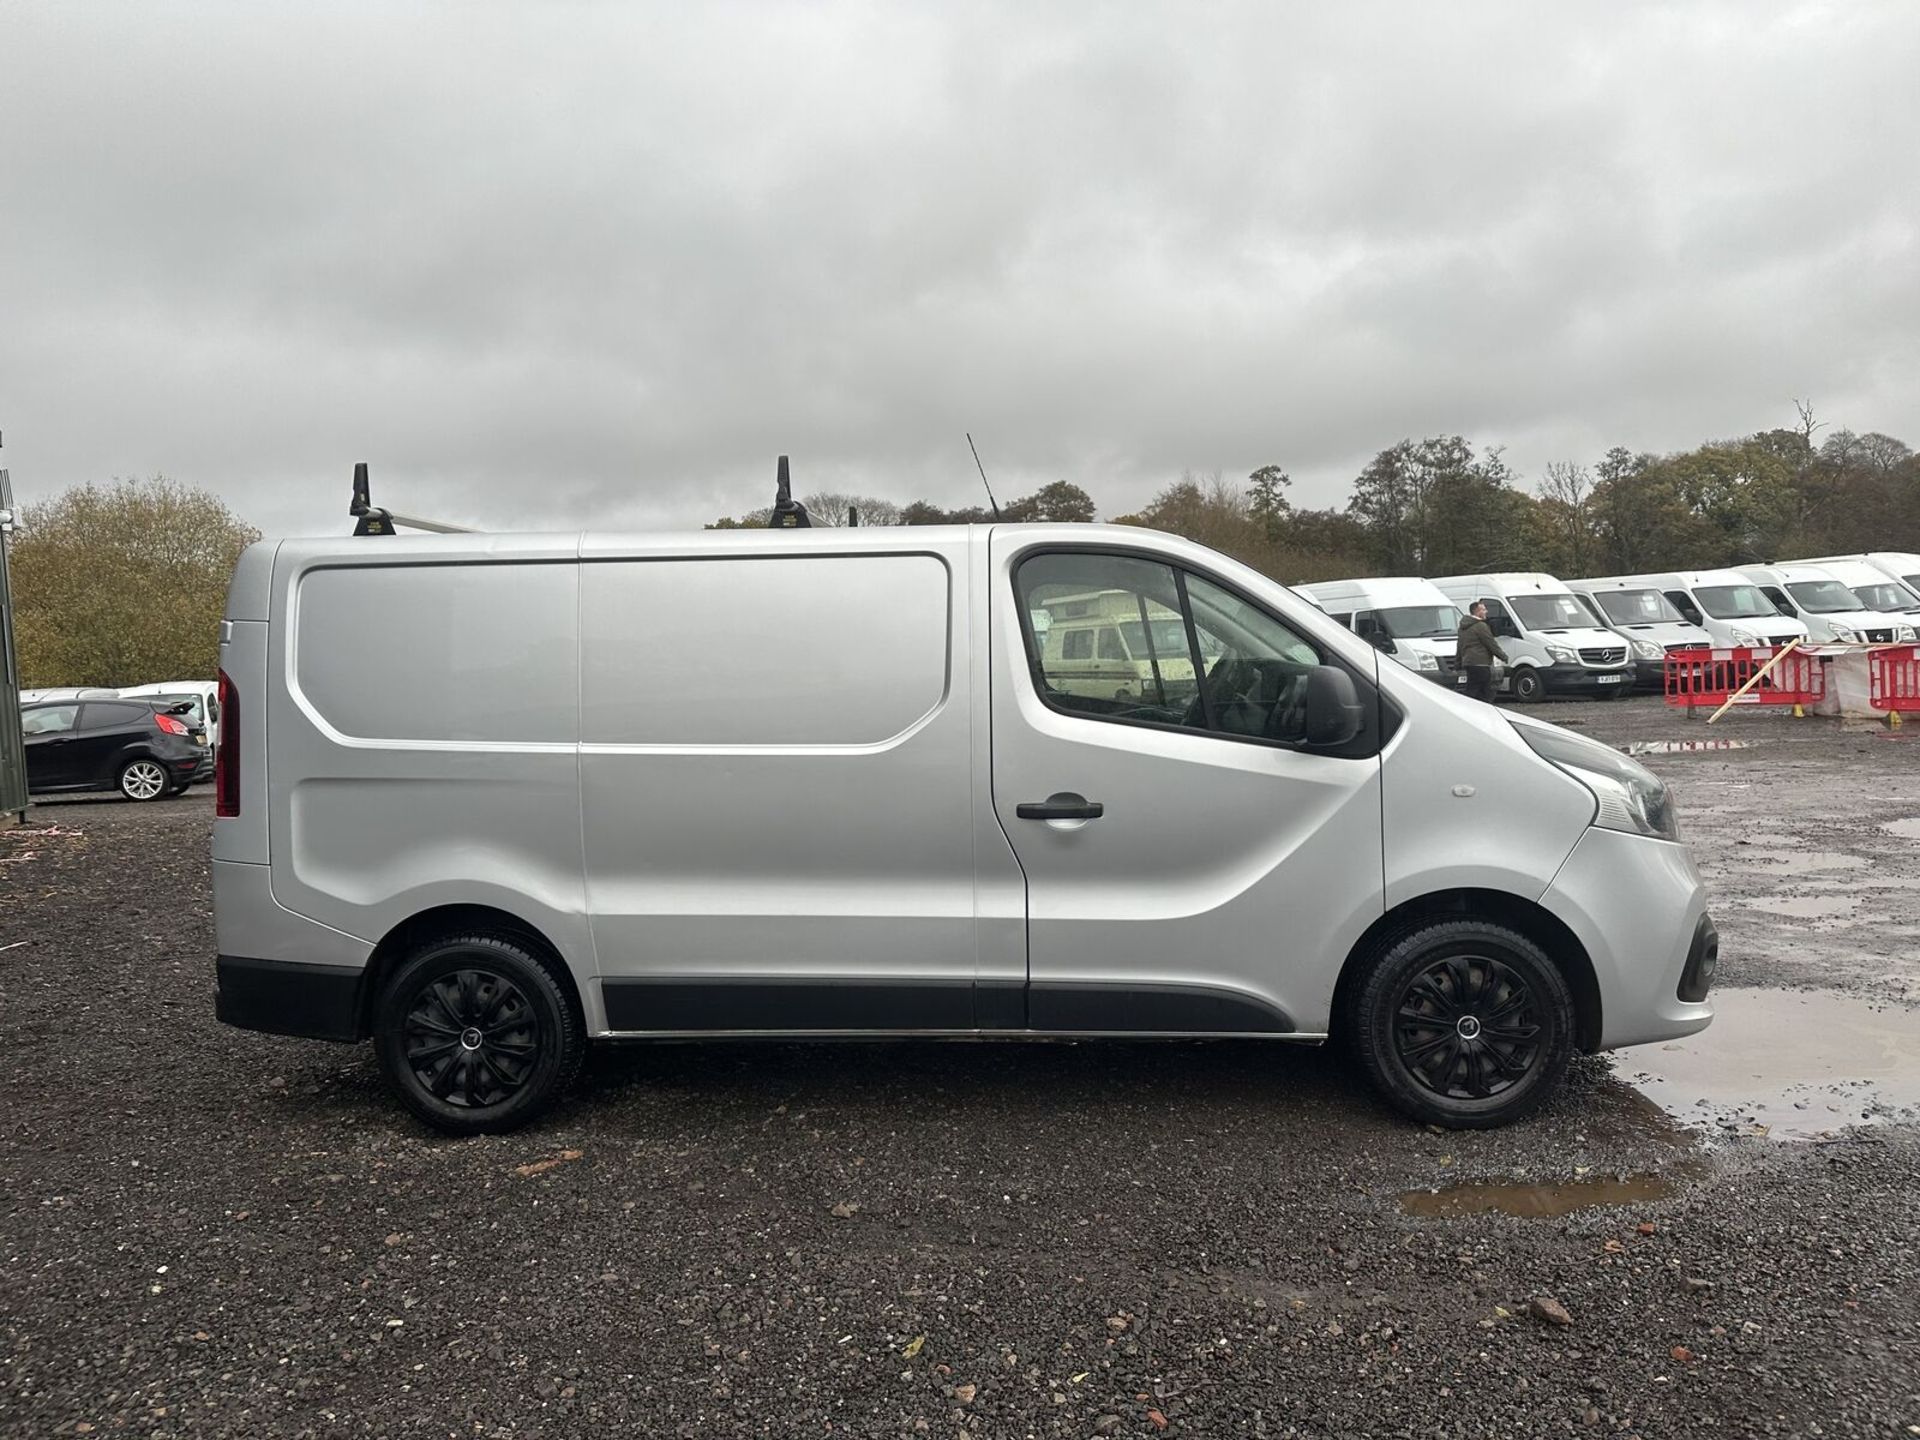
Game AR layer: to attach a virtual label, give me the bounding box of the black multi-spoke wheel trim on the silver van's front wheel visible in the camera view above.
[1394,954,1542,1100]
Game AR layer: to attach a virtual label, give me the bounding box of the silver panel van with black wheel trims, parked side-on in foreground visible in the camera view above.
[213,524,1718,1133]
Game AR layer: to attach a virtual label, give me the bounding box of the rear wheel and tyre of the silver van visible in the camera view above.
[372,933,586,1135]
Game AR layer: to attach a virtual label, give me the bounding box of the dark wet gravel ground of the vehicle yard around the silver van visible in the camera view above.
[0,701,1920,1440]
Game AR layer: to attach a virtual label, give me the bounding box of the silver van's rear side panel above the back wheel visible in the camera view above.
[263,536,595,1027]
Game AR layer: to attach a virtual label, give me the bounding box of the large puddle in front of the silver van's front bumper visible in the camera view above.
[1615,989,1920,1140]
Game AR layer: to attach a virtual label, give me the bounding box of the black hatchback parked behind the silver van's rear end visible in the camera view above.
[19,701,211,801]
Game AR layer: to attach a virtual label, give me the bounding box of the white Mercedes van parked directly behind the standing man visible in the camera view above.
[1434,572,1634,705]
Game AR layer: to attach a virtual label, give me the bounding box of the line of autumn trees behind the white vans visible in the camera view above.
[718,407,1920,584]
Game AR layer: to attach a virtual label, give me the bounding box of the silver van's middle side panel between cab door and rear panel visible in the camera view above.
[580,545,975,1033]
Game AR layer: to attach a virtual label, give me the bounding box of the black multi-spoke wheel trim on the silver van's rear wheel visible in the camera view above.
[401,966,541,1110]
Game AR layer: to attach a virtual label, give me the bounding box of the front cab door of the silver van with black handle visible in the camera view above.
[991,541,1382,1035]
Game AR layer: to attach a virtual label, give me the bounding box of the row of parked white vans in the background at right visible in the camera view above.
[1300,551,1920,701]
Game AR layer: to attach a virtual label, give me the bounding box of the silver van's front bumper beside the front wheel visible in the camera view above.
[1540,828,1718,1050]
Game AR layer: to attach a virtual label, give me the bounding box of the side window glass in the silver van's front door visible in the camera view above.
[1014,551,1321,743]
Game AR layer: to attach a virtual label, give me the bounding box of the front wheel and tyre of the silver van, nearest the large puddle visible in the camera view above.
[1348,920,1574,1129]
